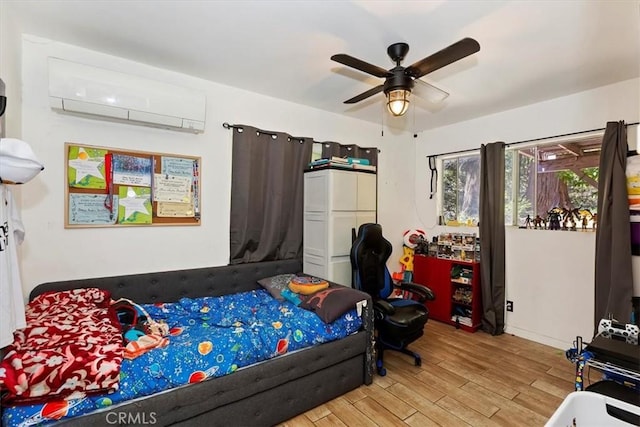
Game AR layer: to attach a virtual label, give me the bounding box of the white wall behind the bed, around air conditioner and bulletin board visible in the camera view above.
[11,36,414,300]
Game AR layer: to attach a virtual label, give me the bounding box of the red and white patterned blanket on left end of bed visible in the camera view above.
[0,288,124,403]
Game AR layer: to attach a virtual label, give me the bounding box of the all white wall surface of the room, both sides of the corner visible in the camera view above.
[0,2,640,348]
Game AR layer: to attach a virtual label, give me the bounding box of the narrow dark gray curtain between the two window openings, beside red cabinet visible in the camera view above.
[480,142,505,335]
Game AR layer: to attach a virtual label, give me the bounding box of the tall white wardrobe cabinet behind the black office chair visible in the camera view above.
[303,169,377,286]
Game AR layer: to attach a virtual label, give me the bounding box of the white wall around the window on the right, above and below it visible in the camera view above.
[415,79,640,348]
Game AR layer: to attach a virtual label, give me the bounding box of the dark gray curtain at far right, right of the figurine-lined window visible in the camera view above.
[594,121,633,331]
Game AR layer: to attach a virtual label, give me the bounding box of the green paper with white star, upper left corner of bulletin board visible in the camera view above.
[67,145,107,190]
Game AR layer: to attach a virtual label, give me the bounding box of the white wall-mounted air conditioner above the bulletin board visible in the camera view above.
[49,57,206,133]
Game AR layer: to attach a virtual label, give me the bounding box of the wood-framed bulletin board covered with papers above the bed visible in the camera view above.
[64,142,202,228]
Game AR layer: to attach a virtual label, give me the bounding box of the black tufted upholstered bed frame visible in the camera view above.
[23,260,373,427]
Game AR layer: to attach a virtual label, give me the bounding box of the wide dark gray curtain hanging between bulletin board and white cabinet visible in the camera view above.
[230,125,313,264]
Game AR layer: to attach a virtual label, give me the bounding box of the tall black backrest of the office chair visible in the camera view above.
[350,223,393,300]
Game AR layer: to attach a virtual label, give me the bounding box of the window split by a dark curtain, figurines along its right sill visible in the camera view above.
[440,134,602,229]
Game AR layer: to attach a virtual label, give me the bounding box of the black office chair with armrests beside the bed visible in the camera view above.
[351,223,434,376]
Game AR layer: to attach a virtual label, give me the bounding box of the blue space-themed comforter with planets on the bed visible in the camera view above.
[2,289,361,426]
